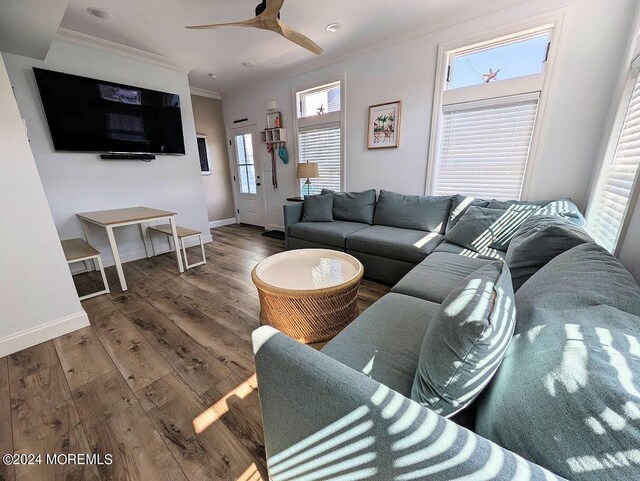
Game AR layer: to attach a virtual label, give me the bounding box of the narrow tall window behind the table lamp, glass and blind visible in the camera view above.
[296,82,342,195]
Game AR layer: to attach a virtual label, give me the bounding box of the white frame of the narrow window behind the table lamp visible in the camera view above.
[290,73,347,196]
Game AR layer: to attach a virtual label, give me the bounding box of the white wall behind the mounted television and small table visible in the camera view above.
[4,40,210,265]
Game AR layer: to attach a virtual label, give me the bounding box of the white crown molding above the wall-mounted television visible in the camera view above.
[55,27,191,73]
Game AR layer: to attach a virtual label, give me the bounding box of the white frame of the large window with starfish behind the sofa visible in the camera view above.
[425,15,564,199]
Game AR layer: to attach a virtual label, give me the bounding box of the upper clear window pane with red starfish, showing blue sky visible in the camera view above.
[447,33,549,89]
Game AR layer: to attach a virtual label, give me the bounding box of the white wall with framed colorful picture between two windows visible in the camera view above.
[223,0,636,231]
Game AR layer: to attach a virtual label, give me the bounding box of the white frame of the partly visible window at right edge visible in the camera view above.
[585,59,640,257]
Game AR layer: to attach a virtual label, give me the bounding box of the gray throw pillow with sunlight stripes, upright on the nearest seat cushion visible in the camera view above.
[411,261,516,417]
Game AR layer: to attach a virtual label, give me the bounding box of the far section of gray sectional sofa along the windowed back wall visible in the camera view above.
[284,190,584,284]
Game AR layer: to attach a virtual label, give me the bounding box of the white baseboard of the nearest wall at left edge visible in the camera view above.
[0,311,89,357]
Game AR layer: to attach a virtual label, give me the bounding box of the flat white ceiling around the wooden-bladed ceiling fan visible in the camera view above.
[0,0,523,91]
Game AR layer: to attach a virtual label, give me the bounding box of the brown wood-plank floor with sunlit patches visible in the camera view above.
[0,225,389,481]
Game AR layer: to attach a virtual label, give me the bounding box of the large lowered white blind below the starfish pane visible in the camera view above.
[433,92,540,199]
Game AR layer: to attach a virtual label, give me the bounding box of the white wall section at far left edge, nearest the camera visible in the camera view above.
[0,53,89,357]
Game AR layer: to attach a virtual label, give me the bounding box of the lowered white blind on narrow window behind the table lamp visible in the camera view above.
[298,124,341,195]
